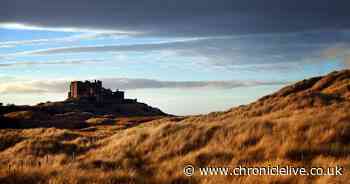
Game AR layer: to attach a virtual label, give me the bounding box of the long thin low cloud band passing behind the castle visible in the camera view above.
[0,78,287,94]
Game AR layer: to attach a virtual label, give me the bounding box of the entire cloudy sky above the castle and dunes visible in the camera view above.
[0,0,350,115]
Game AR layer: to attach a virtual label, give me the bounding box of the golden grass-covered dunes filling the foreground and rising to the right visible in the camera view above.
[0,70,350,184]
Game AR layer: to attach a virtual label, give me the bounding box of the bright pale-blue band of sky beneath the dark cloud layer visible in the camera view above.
[0,26,349,114]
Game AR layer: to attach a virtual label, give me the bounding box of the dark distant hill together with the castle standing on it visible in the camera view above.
[0,81,167,128]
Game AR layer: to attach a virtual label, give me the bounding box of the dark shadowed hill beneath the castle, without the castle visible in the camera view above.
[0,97,167,129]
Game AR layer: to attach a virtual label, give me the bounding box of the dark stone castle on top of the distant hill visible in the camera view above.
[68,80,136,103]
